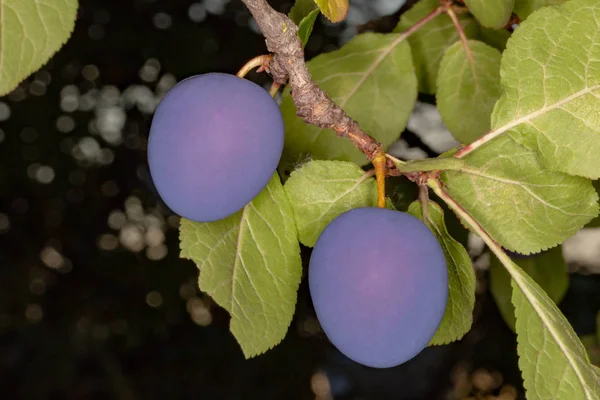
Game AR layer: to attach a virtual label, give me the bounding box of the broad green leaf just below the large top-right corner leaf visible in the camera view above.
[441,136,598,254]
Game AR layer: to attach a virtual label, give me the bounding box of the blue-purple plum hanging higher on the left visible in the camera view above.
[148,73,284,222]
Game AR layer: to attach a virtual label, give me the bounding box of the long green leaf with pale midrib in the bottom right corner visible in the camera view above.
[508,263,600,400]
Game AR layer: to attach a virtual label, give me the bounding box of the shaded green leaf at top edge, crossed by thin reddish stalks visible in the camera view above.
[394,0,478,94]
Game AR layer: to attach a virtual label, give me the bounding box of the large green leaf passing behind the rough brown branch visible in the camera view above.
[281,33,417,165]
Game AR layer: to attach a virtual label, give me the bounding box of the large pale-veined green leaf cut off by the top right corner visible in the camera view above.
[492,0,600,179]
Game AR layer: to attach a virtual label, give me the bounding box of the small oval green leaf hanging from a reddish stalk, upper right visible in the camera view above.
[436,40,501,143]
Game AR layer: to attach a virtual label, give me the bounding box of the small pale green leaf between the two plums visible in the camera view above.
[284,160,377,247]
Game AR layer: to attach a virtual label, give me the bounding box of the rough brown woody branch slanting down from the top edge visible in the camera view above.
[242,0,383,160]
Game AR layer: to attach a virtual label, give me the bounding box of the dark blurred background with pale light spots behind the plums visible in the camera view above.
[0,0,600,400]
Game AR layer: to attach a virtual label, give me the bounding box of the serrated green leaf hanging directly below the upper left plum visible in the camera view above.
[180,174,302,358]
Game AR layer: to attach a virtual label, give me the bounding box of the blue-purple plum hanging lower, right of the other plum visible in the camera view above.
[308,207,448,368]
